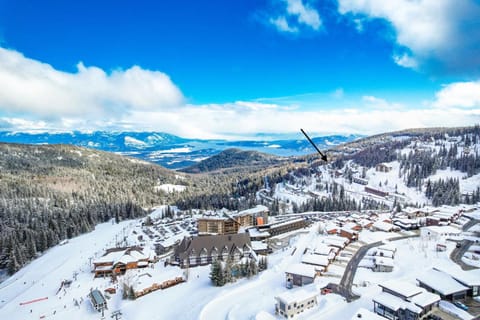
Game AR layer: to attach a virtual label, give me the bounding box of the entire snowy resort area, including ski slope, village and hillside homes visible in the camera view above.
[0,132,480,320]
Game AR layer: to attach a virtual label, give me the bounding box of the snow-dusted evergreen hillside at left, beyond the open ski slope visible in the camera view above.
[0,144,178,272]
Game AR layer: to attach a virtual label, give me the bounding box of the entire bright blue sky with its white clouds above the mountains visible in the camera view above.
[0,0,480,138]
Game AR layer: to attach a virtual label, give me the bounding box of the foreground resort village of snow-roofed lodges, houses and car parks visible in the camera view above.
[2,199,480,319]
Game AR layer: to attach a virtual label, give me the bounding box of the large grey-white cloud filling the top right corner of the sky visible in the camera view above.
[338,0,480,72]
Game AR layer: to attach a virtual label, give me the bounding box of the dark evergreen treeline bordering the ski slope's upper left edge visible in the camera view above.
[0,199,145,274]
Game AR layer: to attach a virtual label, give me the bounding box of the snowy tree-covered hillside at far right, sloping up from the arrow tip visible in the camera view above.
[334,125,480,206]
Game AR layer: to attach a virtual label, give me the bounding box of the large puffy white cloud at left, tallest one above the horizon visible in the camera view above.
[0,48,183,119]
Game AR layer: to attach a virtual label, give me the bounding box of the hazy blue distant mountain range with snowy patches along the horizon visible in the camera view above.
[0,131,363,169]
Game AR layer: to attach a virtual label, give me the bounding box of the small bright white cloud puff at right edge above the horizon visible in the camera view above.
[433,80,480,109]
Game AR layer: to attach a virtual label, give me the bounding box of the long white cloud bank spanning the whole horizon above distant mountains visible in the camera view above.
[0,48,480,139]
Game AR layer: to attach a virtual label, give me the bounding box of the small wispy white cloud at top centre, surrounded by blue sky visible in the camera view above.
[268,0,322,33]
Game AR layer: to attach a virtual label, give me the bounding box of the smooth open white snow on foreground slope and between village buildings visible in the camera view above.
[0,209,478,320]
